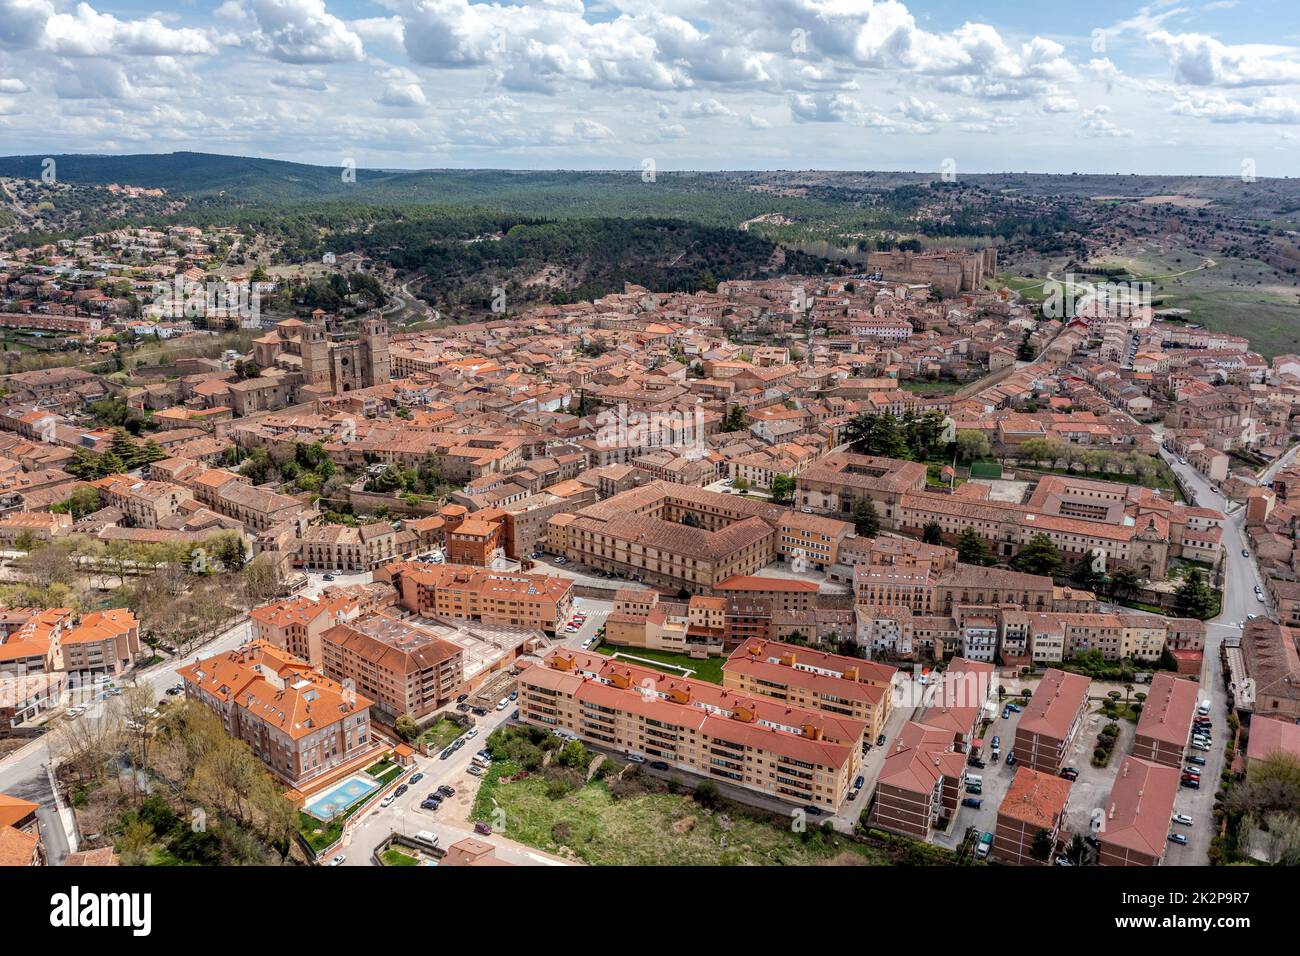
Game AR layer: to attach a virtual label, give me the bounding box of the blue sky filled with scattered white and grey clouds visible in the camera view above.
[0,0,1300,177]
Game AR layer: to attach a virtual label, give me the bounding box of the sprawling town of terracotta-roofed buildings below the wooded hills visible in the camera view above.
[0,214,1300,868]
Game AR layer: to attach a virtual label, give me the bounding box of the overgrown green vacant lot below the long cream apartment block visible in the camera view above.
[475,766,889,866]
